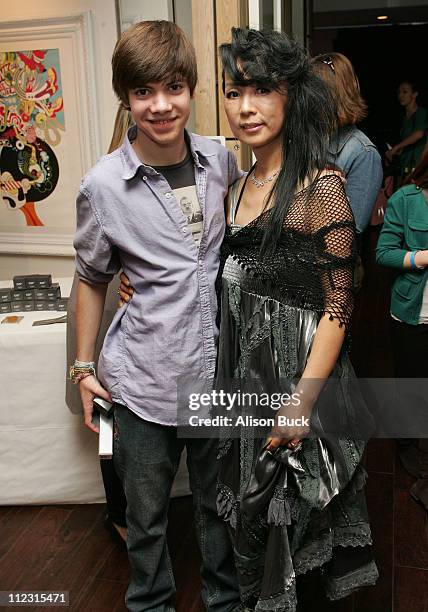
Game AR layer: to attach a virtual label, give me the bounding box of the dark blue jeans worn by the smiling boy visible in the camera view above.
[114,404,239,612]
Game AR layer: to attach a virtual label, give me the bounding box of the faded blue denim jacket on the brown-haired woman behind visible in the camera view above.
[329,125,383,234]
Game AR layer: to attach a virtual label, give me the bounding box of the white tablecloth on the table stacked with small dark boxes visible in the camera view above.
[0,278,188,505]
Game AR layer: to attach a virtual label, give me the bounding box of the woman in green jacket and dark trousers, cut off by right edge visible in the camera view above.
[376,151,428,510]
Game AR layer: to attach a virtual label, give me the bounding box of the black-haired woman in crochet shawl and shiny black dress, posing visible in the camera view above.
[122,29,377,612]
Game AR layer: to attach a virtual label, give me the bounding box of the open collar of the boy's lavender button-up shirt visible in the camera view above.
[121,125,215,180]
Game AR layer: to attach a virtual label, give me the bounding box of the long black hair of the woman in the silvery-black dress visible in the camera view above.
[220,28,337,252]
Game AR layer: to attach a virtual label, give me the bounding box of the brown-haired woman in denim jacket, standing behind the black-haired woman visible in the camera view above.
[313,53,382,234]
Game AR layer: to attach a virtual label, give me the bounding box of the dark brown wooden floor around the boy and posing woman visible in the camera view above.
[0,231,428,612]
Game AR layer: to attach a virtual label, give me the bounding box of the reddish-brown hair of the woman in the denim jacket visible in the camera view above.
[312,53,367,127]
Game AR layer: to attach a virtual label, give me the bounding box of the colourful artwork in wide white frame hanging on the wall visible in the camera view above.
[0,11,101,256]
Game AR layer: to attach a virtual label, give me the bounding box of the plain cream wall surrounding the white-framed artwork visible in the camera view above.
[0,0,117,280]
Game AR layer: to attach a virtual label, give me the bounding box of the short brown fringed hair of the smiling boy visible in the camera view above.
[111,21,198,107]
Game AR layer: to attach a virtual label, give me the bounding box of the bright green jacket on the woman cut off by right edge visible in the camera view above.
[376,185,428,325]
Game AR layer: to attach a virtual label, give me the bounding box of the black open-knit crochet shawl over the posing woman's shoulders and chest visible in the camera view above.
[220,174,356,326]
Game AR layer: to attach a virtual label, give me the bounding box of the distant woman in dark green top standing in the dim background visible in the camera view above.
[386,81,428,185]
